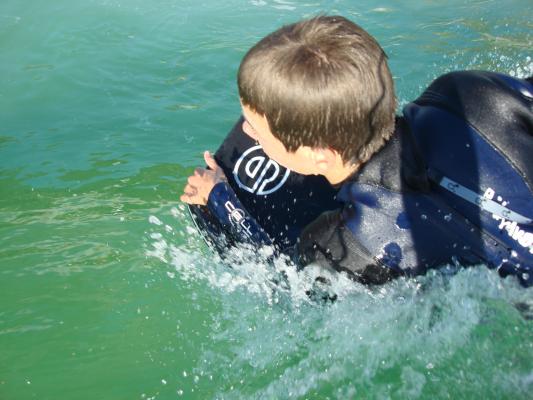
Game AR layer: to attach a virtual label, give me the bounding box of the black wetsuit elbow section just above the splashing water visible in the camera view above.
[295,210,400,284]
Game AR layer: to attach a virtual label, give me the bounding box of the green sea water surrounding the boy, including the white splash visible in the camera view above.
[0,0,533,399]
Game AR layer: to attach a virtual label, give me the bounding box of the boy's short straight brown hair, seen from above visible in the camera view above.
[238,16,396,168]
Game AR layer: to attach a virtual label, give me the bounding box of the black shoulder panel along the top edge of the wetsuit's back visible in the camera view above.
[412,71,533,190]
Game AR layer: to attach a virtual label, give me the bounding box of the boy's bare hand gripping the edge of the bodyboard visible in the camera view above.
[180,151,227,206]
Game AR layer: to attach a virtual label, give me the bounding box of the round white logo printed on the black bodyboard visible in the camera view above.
[233,145,291,195]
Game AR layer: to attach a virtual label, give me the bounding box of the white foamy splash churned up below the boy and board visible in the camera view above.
[145,213,533,399]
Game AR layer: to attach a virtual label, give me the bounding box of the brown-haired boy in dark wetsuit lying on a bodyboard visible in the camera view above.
[181,16,533,285]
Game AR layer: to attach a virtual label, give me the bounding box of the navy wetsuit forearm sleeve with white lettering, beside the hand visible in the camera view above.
[207,182,272,246]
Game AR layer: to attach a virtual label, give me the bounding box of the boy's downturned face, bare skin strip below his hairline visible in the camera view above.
[242,105,320,175]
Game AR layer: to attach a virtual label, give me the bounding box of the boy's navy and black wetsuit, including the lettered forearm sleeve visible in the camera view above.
[190,72,533,286]
